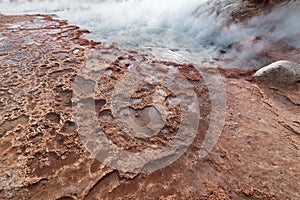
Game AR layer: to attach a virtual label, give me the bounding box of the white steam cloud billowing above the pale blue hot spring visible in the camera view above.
[0,0,300,68]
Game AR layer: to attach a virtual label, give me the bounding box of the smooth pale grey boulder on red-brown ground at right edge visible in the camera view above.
[253,60,300,85]
